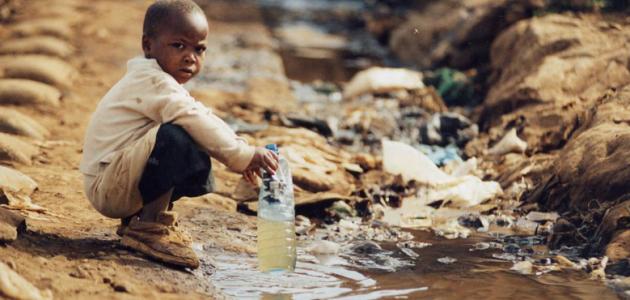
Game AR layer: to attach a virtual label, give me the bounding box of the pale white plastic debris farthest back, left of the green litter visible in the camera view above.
[343,67,424,99]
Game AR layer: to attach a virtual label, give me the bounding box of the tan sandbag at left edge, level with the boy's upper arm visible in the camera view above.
[0,107,50,140]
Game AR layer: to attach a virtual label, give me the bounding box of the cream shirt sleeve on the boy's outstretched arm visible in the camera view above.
[148,75,255,172]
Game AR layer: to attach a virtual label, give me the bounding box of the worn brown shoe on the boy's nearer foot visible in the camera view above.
[121,218,199,269]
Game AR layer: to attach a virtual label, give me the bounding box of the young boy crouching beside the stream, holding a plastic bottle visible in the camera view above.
[80,0,278,268]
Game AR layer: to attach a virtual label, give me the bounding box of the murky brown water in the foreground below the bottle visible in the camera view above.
[209,231,616,299]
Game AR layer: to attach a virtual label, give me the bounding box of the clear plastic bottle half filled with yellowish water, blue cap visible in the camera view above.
[258,144,297,272]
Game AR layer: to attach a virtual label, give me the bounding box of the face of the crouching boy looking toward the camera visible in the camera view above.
[142,13,208,84]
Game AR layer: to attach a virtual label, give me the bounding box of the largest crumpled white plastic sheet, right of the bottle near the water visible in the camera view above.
[382,140,502,207]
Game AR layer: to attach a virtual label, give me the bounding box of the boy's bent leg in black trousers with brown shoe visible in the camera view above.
[122,124,212,268]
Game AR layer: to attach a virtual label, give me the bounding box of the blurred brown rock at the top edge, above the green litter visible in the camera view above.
[389,0,542,69]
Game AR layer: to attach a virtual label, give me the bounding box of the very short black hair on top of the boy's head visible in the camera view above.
[142,0,205,37]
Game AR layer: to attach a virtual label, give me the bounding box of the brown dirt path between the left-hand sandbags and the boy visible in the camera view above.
[0,0,276,299]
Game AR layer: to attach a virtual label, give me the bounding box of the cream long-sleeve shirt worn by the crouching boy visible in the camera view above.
[79,57,254,176]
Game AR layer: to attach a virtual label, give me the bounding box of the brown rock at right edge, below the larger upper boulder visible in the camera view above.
[526,86,630,255]
